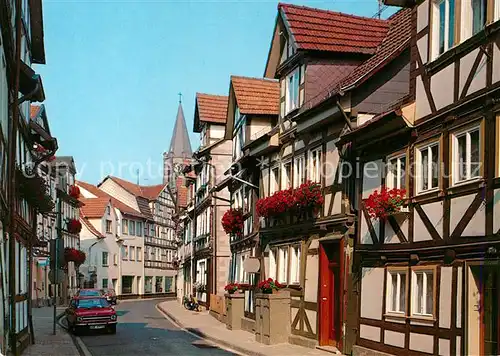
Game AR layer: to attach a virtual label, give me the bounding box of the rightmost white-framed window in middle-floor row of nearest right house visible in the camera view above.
[452,125,482,185]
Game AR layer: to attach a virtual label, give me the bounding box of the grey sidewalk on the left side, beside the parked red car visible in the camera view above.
[23,307,80,356]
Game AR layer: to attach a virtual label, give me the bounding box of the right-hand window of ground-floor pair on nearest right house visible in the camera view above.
[411,270,434,316]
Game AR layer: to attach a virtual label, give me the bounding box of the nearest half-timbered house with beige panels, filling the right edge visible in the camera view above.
[339,0,500,355]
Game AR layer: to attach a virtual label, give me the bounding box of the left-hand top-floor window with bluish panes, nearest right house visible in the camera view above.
[433,0,455,58]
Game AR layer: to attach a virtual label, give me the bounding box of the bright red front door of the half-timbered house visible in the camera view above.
[318,240,344,350]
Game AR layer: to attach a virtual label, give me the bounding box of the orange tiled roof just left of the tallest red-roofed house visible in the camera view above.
[231,75,280,115]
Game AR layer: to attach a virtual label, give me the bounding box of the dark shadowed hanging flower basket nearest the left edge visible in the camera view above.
[16,167,55,214]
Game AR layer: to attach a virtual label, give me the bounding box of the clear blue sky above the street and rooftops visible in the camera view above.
[36,0,392,184]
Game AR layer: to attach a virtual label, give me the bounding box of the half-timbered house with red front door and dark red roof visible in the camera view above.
[259,4,410,353]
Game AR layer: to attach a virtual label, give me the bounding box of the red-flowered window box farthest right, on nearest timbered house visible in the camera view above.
[365,187,406,220]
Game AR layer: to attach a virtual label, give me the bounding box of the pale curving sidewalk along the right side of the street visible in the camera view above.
[158,301,332,356]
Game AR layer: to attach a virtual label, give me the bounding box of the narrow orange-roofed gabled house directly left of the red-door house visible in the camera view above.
[218,76,279,322]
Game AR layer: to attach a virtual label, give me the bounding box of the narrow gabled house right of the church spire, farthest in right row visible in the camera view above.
[184,93,231,308]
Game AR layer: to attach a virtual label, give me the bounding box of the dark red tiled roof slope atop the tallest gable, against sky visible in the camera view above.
[278,4,389,54]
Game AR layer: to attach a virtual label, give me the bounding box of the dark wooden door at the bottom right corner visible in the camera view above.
[481,267,500,355]
